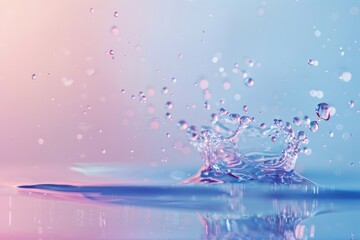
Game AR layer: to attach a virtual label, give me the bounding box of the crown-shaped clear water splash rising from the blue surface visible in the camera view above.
[184,103,330,184]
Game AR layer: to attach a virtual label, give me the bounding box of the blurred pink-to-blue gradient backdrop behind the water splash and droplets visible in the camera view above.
[0,0,360,238]
